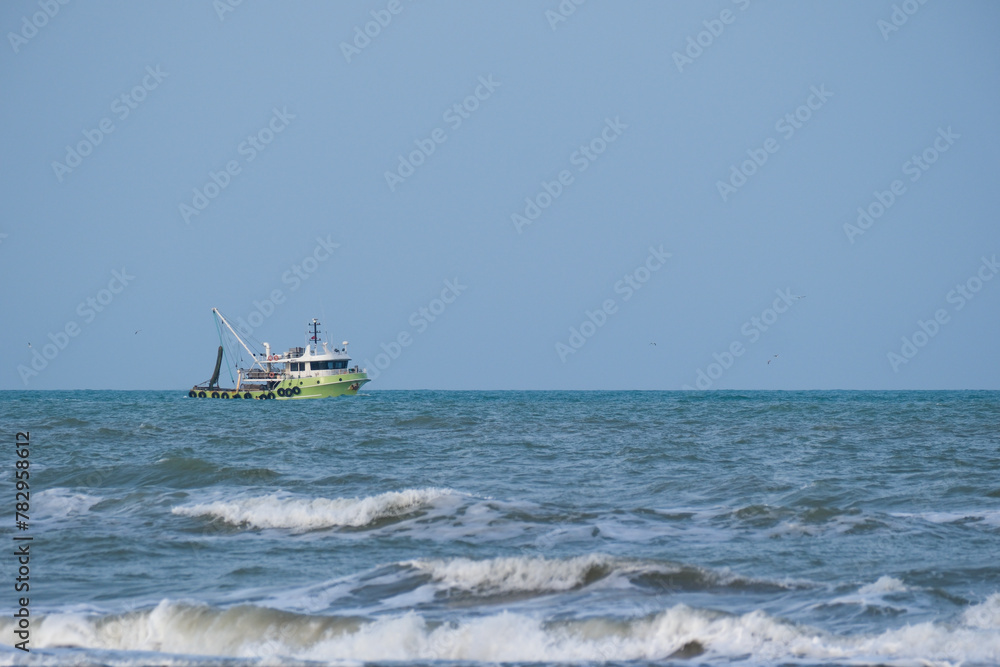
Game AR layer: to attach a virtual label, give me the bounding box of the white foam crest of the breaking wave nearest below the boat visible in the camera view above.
[171,488,459,531]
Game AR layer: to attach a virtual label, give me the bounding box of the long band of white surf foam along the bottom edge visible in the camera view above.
[7,594,1000,664]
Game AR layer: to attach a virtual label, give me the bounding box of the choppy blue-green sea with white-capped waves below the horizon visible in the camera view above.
[0,389,1000,667]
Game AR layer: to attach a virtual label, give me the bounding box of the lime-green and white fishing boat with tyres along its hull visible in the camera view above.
[188,308,369,400]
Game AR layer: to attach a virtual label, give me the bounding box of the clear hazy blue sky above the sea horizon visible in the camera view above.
[0,0,1000,390]
